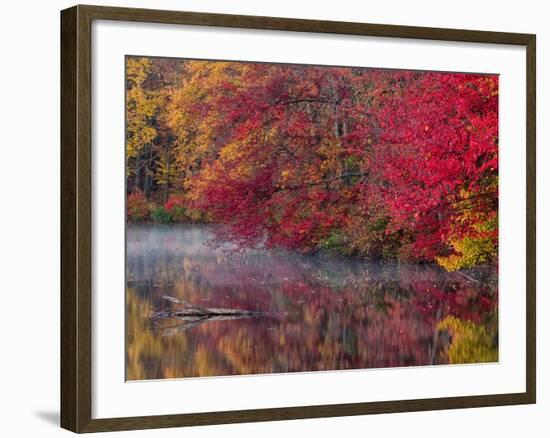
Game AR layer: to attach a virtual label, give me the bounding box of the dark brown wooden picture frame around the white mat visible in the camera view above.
[61,5,536,433]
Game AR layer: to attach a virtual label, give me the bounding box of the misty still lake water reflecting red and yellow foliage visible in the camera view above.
[126,225,498,380]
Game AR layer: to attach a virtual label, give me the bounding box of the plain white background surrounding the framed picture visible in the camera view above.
[0,0,550,438]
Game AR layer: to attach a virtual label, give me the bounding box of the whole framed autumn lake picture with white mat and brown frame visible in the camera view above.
[61,6,536,432]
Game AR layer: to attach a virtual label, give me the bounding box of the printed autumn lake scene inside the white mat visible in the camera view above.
[126,56,499,379]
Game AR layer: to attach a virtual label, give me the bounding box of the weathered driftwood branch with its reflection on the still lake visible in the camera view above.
[151,295,268,334]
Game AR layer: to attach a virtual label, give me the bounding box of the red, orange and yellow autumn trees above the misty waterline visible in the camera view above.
[127,58,498,270]
